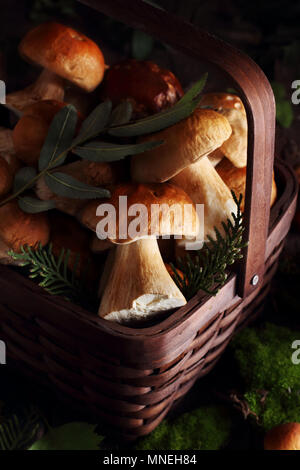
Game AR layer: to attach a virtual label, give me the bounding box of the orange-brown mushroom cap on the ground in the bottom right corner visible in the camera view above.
[264,423,300,450]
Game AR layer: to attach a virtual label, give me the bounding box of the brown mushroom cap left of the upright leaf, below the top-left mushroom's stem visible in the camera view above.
[12,100,66,165]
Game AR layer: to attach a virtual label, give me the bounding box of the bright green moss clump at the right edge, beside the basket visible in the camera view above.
[231,323,300,430]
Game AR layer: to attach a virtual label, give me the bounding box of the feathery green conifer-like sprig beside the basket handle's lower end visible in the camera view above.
[171,191,247,300]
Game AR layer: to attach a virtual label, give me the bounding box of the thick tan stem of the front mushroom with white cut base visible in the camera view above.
[98,238,186,323]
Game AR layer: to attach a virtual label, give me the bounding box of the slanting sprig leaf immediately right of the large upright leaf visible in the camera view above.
[73,101,112,146]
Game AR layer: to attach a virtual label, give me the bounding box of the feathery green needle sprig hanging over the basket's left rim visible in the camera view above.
[8,243,93,303]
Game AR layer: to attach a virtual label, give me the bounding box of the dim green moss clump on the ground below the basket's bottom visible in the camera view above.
[135,406,231,450]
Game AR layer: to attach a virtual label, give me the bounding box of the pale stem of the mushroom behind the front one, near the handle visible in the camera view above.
[170,157,236,241]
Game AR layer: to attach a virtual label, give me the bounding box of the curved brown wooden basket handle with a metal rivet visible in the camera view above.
[79,0,275,297]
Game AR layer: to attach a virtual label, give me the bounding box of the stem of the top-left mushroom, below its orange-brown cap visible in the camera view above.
[6,69,65,111]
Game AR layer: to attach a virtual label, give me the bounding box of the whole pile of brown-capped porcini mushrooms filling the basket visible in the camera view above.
[0,22,276,324]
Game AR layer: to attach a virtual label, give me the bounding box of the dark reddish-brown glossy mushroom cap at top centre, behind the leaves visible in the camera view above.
[103,59,183,115]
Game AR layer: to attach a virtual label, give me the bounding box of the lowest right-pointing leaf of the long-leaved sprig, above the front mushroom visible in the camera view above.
[45,172,110,199]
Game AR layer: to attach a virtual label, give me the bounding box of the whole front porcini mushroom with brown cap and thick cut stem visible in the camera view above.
[80,183,198,323]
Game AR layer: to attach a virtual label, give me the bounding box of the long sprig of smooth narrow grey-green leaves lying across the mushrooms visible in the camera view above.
[0,74,207,213]
